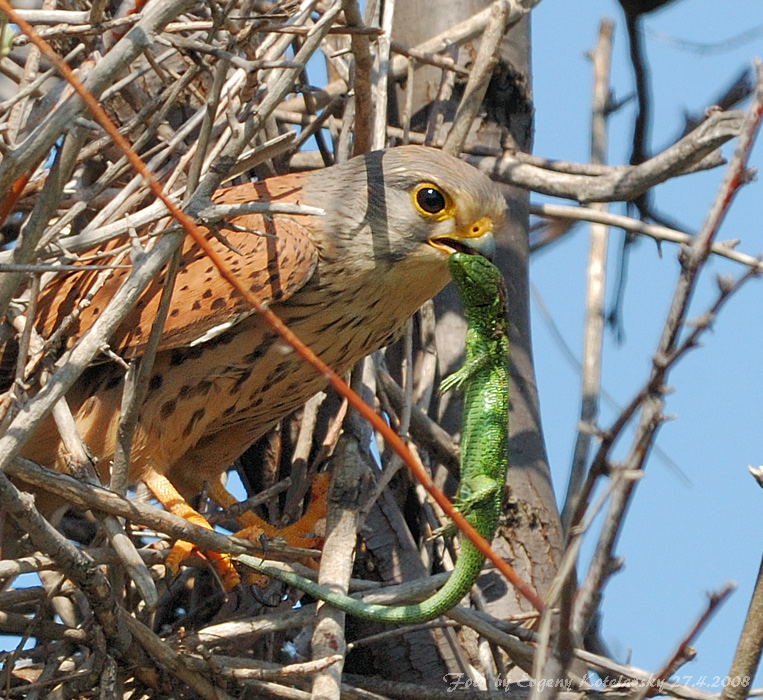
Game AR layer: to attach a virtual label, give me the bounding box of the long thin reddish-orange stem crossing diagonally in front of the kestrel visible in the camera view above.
[0,0,543,611]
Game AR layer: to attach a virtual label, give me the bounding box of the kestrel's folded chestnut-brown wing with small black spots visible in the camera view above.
[33,178,317,354]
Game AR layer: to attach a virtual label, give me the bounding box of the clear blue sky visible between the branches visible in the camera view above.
[530,0,763,692]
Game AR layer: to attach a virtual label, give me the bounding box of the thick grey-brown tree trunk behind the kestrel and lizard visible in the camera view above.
[352,0,561,682]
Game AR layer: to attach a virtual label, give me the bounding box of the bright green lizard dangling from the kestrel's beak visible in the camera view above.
[236,252,509,624]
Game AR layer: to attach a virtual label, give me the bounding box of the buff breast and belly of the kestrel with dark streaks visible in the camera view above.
[146,251,448,493]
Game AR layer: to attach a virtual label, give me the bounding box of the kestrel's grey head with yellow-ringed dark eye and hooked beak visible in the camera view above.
[306,146,506,274]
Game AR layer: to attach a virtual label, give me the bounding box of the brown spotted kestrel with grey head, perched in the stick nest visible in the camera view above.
[5,146,506,584]
